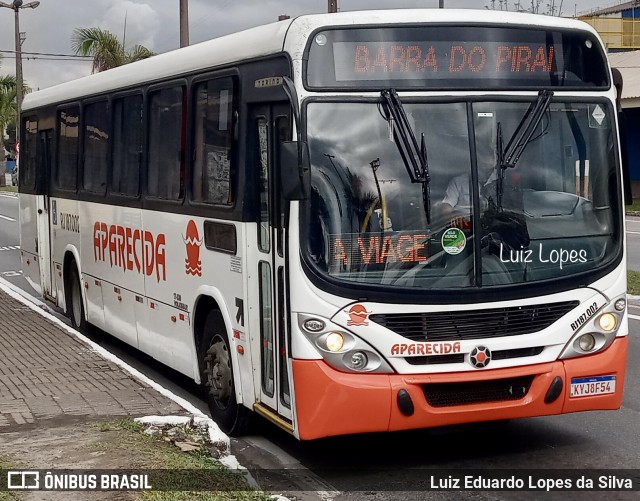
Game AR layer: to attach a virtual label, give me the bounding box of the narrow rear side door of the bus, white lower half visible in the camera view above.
[36,129,57,300]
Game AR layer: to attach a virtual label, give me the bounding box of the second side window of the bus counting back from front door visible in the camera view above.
[147,87,184,200]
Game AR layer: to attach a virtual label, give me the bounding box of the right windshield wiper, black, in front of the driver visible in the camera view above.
[496,89,553,210]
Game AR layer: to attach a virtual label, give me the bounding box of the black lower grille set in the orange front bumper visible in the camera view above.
[422,376,533,407]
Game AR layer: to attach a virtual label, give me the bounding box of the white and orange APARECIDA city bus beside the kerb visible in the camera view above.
[19,9,628,440]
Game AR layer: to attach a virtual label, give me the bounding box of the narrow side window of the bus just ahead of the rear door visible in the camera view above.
[56,106,79,191]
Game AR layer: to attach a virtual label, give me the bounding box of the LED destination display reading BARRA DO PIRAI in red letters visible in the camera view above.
[333,41,555,81]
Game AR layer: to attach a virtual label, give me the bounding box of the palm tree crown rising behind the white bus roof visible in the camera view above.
[71,28,154,73]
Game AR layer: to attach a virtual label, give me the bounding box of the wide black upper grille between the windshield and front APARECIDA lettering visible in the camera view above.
[369,301,580,342]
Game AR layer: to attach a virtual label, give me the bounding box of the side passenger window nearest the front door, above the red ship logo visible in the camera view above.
[192,77,236,205]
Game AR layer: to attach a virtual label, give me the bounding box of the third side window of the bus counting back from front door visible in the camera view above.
[111,95,142,197]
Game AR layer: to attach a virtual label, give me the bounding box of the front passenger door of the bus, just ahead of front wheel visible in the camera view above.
[250,103,291,420]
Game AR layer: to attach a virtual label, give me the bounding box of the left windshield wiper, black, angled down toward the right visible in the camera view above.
[380,89,431,223]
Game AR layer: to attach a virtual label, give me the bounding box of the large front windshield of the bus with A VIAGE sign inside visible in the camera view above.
[303,98,621,290]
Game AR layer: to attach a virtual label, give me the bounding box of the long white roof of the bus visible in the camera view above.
[22,9,599,111]
